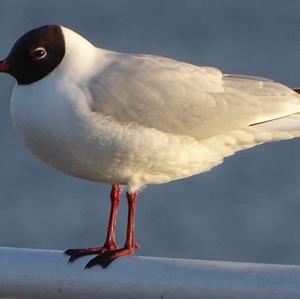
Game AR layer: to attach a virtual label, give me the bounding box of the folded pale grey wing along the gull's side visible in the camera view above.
[89,54,300,139]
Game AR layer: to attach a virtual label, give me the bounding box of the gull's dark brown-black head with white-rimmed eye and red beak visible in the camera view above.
[0,25,65,85]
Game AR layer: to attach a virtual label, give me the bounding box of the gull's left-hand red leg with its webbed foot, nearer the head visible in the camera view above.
[65,185,121,262]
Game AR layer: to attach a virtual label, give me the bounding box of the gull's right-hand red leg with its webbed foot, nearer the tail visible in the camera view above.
[85,192,139,268]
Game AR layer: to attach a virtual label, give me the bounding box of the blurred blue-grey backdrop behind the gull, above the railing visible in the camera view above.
[0,0,300,264]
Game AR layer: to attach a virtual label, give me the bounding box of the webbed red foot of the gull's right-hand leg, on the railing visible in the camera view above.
[84,244,138,269]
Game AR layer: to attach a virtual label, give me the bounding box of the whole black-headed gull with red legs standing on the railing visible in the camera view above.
[0,25,300,268]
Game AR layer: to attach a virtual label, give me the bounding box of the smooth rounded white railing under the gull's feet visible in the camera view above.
[0,247,300,299]
